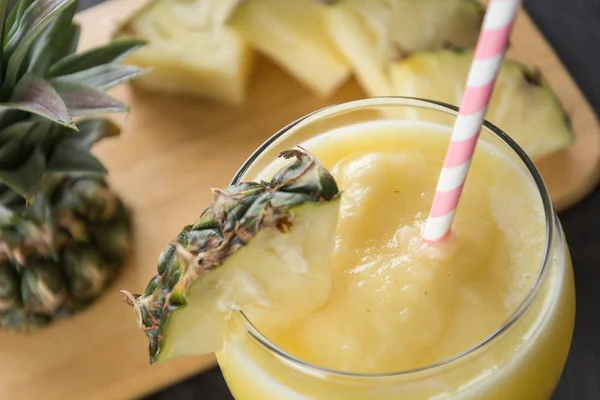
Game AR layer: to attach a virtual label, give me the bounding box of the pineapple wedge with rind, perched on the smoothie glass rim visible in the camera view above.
[124,150,340,362]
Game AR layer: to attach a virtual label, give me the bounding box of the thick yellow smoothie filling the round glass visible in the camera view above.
[217,117,574,400]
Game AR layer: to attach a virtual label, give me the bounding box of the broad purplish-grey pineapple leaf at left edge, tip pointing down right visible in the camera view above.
[0,74,77,129]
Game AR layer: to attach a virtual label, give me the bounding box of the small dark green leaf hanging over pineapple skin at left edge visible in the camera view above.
[0,147,45,203]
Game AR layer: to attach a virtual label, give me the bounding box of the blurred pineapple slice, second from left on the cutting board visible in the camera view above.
[229,0,351,97]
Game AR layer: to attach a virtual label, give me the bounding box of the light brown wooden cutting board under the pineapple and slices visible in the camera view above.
[0,0,600,400]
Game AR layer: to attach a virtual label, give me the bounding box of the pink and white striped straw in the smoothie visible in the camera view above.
[423,0,521,242]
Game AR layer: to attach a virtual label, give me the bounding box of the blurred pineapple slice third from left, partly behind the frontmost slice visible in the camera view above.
[328,0,484,96]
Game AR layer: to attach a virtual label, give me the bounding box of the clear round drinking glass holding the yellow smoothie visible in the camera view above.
[217,97,575,400]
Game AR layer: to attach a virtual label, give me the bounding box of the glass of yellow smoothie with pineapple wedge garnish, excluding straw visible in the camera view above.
[122,98,575,400]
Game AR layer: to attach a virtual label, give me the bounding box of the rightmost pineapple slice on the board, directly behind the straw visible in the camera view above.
[391,50,574,159]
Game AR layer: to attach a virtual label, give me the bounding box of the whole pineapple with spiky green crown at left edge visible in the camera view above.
[0,0,143,331]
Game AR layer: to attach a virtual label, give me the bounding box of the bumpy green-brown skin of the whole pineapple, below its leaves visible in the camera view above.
[0,178,131,332]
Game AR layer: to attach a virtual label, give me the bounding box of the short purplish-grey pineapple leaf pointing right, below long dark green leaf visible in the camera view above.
[54,82,128,116]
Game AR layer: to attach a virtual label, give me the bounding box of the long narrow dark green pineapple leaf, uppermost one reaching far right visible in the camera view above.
[48,39,146,77]
